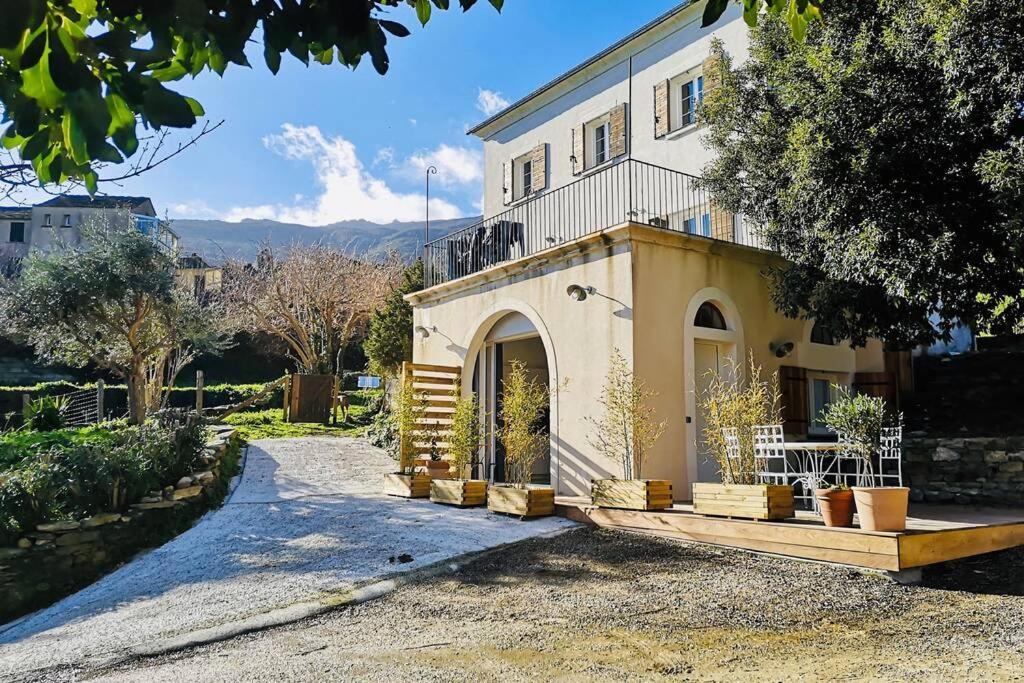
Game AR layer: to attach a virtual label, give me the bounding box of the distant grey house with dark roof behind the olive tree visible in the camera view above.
[27,195,178,252]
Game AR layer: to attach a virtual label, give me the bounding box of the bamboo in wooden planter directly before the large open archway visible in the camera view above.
[487,360,555,517]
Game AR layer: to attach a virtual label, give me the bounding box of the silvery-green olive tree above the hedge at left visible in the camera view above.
[0,214,228,424]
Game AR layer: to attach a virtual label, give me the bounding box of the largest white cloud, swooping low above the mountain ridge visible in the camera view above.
[224,123,463,225]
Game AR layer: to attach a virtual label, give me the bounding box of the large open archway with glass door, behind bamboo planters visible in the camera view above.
[472,312,553,484]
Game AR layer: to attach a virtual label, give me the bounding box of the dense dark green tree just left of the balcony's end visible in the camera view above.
[362,259,423,377]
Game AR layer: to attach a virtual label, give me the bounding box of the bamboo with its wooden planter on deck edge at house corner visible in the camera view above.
[587,348,673,510]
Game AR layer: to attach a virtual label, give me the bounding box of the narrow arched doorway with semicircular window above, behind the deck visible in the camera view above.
[684,288,743,489]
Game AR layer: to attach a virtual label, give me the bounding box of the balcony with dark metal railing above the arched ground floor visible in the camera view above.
[423,160,764,287]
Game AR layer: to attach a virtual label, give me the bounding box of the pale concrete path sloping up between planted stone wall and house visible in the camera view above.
[0,438,571,680]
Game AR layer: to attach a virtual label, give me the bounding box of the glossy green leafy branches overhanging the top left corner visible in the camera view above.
[0,0,503,193]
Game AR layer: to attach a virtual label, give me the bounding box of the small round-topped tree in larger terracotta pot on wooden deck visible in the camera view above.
[822,387,910,531]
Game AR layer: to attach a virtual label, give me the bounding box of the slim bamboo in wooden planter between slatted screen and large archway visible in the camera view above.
[430,384,487,508]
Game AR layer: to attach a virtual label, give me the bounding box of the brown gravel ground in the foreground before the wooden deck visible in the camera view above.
[86,528,1024,683]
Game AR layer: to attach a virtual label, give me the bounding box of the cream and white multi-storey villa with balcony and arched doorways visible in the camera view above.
[408,2,887,500]
